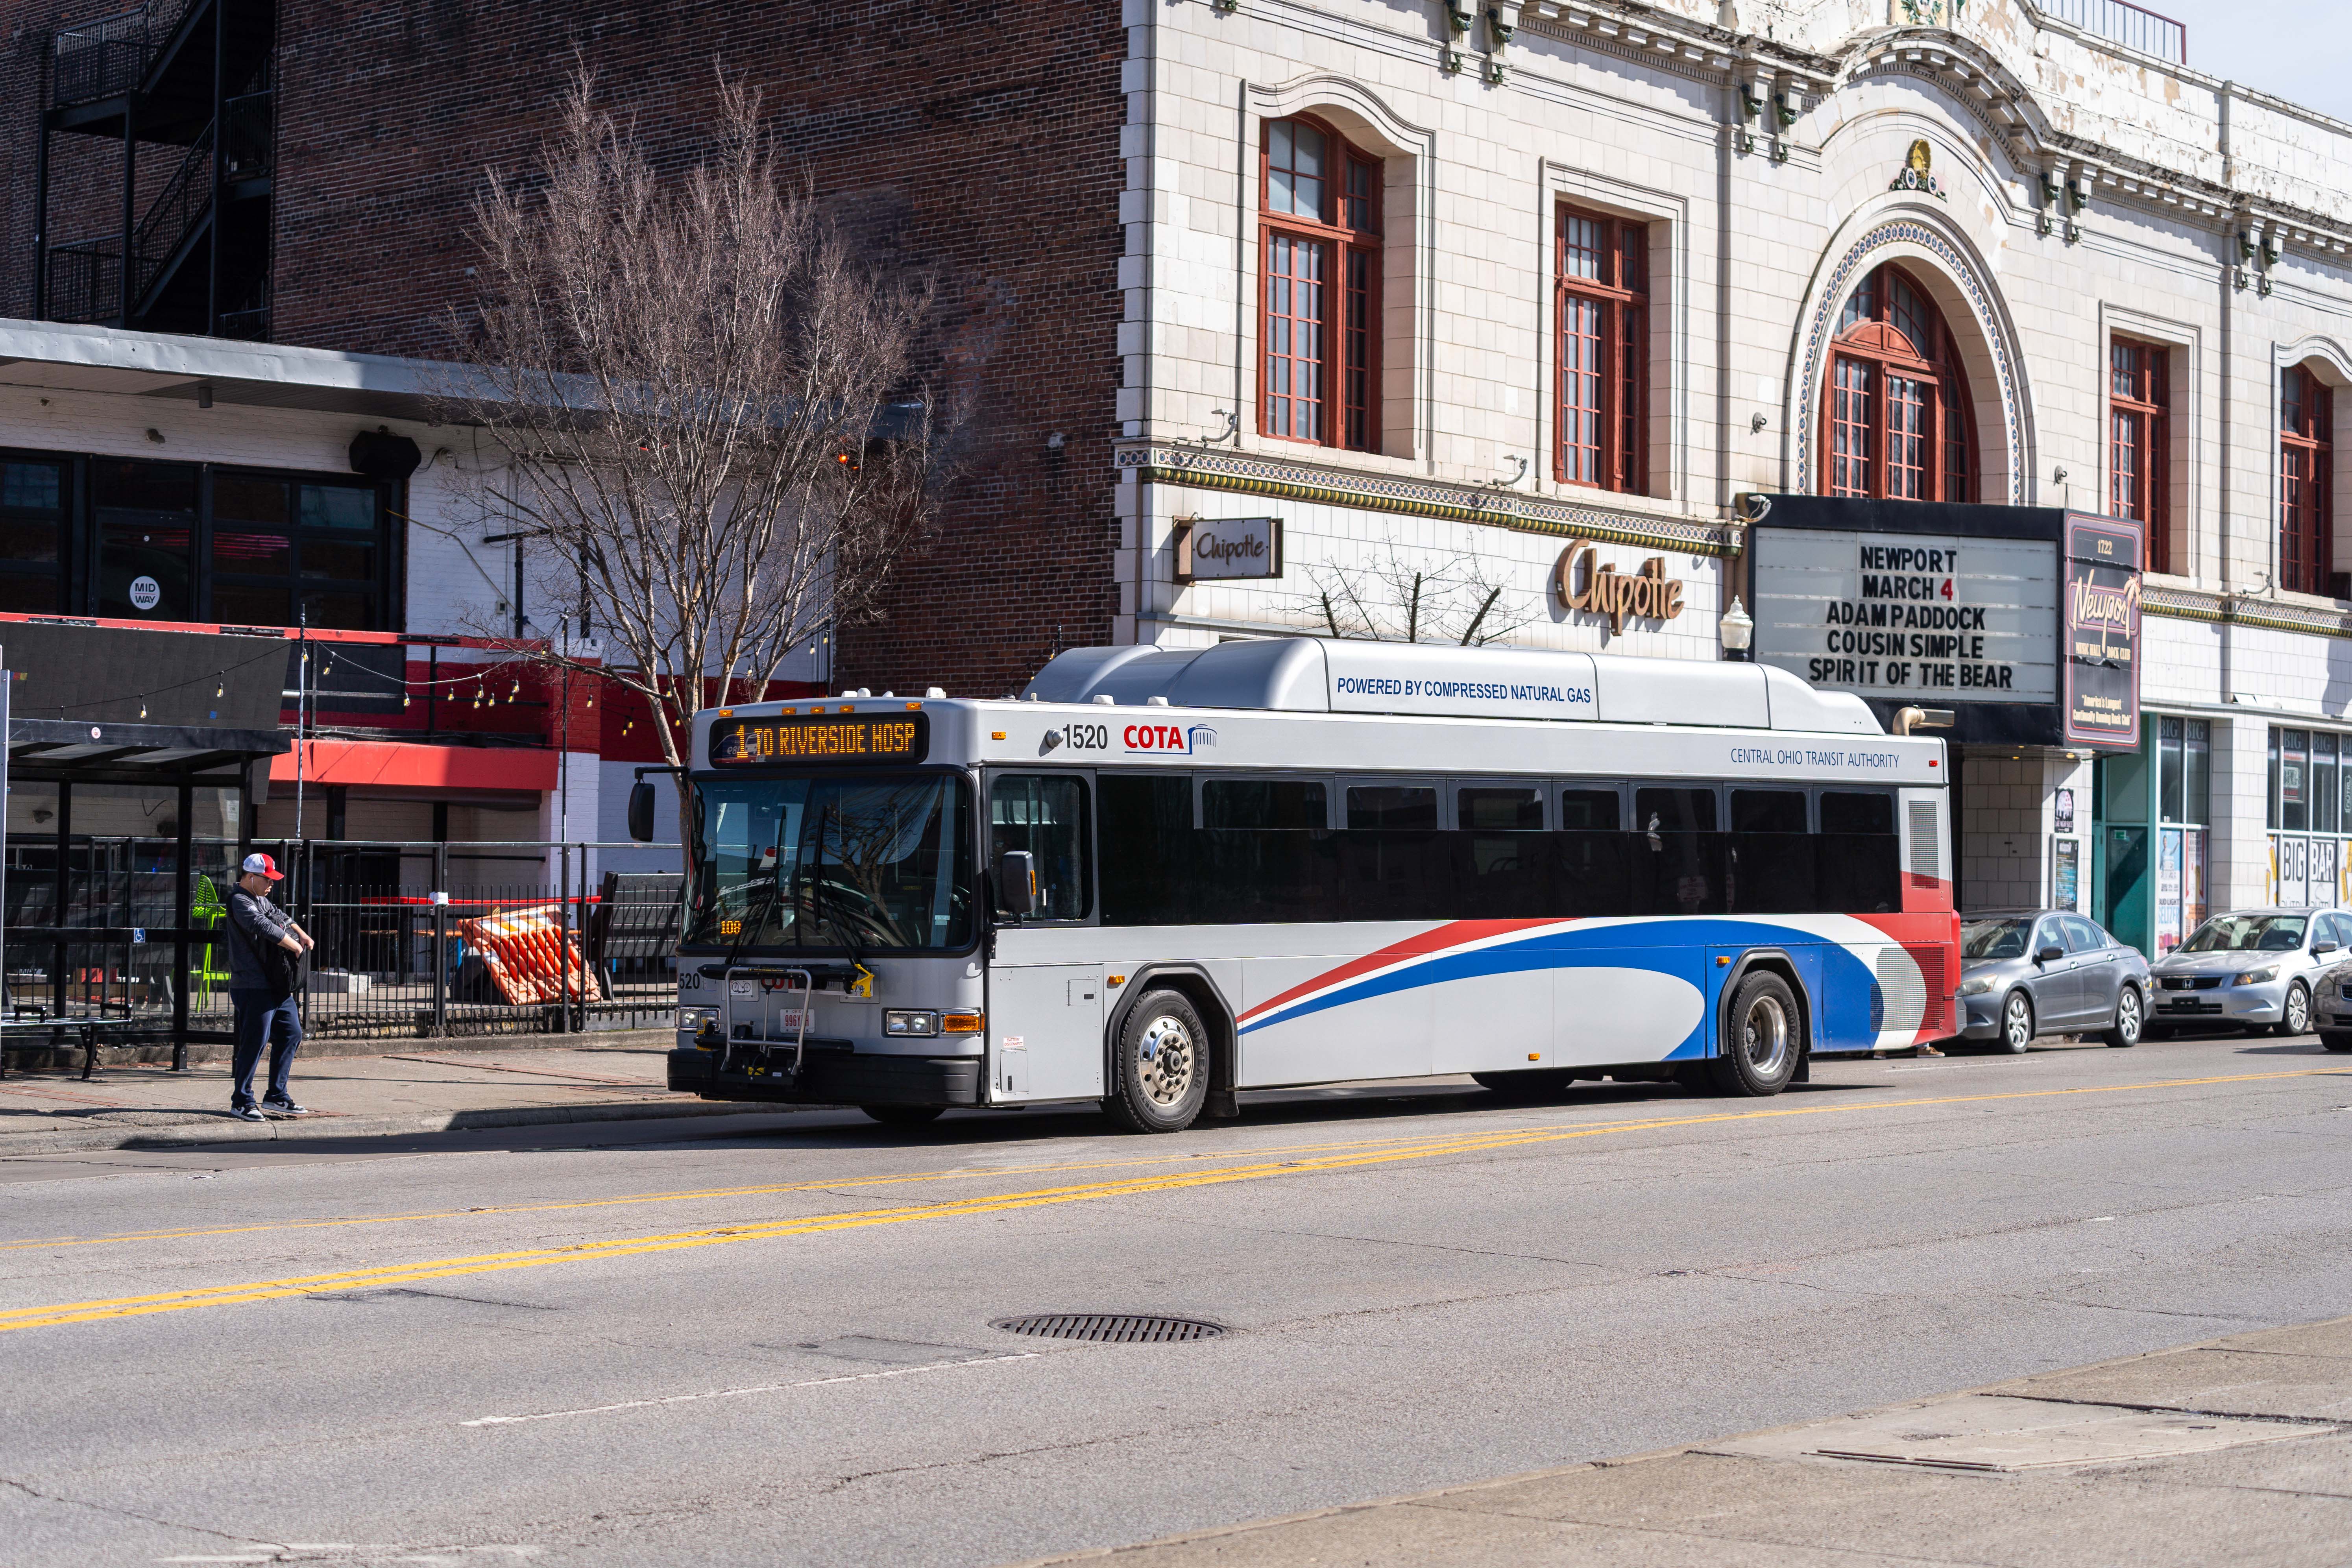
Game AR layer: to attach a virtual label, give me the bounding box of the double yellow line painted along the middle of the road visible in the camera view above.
[0,1069,2347,1333]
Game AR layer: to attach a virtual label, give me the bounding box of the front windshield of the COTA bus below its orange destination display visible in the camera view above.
[682,774,972,952]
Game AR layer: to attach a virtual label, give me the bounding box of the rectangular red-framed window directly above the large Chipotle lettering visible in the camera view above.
[1552,207,1649,494]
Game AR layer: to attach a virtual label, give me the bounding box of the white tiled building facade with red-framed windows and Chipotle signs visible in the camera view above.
[1117,0,2352,945]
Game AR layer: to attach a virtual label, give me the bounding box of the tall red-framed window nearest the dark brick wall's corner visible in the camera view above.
[1258,115,1380,451]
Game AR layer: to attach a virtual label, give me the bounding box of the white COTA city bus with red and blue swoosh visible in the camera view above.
[654,637,1959,1133]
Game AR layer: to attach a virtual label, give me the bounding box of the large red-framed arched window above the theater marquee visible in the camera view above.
[1823,266,1976,501]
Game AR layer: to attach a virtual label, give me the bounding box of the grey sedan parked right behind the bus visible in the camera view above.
[1957,910,2150,1051]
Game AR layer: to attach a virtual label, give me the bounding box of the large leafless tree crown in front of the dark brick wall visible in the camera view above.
[445,70,955,764]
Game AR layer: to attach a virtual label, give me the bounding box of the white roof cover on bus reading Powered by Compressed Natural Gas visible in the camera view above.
[1023,637,1886,736]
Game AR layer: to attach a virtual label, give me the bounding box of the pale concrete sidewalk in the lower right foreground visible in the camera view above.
[1030,1319,2352,1568]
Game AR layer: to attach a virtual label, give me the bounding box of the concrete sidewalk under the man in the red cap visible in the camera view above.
[0,1030,795,1159]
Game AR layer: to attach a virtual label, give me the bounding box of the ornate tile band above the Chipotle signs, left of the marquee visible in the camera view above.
[1117,442,1748,555]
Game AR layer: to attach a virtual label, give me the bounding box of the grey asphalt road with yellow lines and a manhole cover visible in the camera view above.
[0,1039,2352,1568]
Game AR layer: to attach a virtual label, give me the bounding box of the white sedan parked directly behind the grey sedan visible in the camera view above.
[2150,910,2352,1034]
